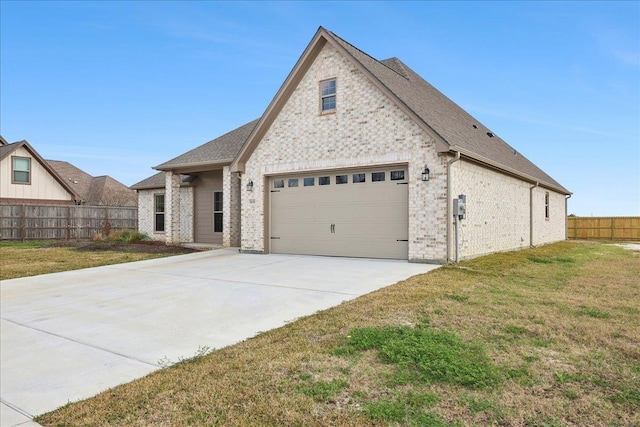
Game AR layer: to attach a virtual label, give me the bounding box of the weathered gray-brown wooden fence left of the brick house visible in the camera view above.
[0,205,138,240]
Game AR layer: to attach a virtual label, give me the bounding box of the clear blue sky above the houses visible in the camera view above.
[0,0,640,216]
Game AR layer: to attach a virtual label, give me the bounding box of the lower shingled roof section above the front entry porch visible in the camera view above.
[155,120,258,172]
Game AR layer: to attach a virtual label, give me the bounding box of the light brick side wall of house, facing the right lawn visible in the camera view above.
[451,160,565,259]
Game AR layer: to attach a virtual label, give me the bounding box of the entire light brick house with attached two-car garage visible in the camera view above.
[133,27,571,263]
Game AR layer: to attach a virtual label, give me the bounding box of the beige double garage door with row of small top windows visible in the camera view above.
[269,167,409,259]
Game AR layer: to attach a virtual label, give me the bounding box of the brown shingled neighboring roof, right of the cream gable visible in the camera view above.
[47,160,137,206]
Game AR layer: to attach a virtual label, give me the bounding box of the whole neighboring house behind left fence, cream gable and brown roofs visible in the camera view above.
[0,137,137,207]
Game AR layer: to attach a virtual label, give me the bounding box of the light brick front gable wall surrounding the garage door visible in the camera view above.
[240,45,447,261]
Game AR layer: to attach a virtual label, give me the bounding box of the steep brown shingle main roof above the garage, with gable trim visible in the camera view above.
[231,27,570,194]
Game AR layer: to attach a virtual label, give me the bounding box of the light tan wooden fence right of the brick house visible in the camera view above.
[567,216,640,241]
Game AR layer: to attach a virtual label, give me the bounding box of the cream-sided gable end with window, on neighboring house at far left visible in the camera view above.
[0,137,80,205]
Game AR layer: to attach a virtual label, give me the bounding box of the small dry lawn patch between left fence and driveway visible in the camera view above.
[0,241,180,280]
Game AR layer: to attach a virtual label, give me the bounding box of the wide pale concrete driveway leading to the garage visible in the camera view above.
[0,249,436,426]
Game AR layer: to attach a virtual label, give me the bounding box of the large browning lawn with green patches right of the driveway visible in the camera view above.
[37,242,640,426]
